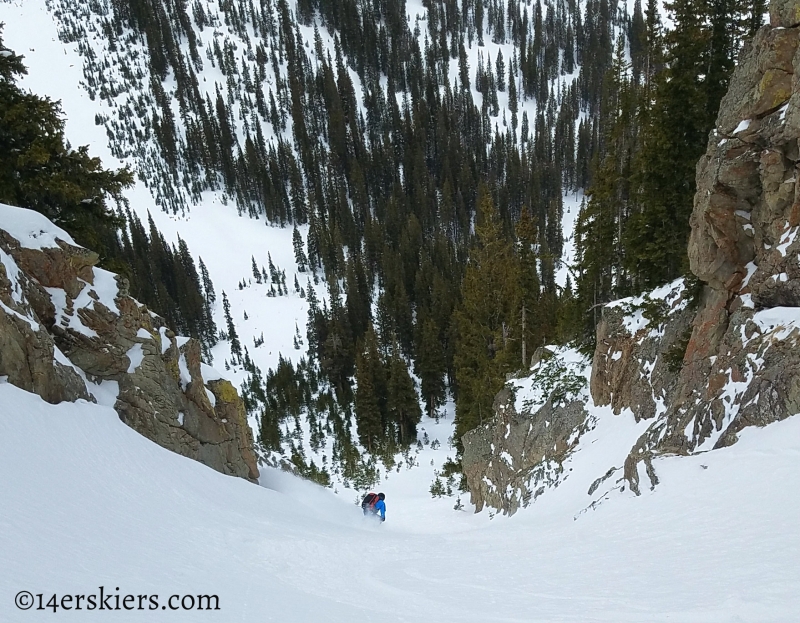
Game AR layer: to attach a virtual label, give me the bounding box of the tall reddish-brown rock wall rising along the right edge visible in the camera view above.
[608,2,800,490]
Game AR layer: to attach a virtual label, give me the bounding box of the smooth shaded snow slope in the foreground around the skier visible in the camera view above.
[0,383,800,623]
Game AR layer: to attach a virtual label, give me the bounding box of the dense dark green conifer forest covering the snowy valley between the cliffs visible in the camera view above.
[0,0,766,487]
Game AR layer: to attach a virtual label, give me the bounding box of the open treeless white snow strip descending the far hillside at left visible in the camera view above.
[0,0,325,372]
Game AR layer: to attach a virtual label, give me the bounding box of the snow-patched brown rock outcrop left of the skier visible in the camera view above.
[0,206,258,481]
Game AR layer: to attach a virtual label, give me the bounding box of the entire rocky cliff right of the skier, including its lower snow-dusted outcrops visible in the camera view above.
[463,7,800,513]
